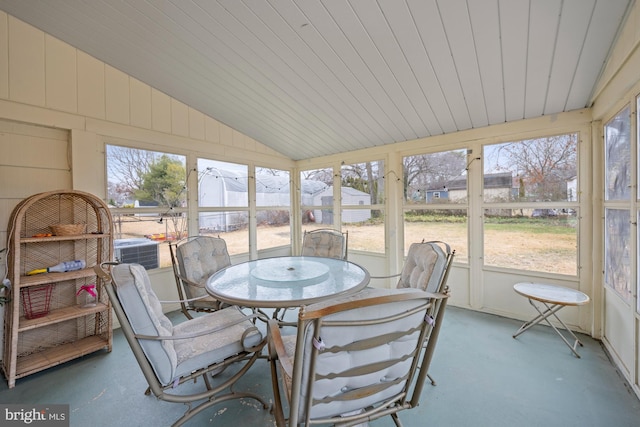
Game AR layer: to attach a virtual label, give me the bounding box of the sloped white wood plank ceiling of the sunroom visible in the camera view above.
[0,0,634,160]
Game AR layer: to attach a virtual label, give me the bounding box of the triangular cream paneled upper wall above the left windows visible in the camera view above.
[0,12,289,162]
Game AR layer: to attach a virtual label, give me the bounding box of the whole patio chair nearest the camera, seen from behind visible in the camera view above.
[269,288,448,427]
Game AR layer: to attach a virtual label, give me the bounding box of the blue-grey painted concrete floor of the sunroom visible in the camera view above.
[0,307,640,427]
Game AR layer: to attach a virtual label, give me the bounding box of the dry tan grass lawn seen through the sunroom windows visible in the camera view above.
[116,217,578,275]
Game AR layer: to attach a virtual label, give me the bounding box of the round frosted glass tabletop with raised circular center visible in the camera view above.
[206,256,369,308]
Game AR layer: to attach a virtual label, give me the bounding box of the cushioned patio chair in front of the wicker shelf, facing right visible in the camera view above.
[95,264,268,426]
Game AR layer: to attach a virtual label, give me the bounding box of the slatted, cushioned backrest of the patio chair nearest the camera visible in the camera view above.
[290,288,446,425]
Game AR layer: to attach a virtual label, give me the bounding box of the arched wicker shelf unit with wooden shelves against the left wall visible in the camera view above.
[2,190,113,388]
